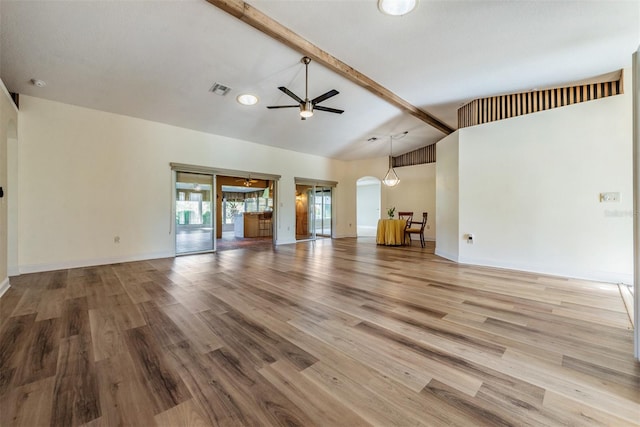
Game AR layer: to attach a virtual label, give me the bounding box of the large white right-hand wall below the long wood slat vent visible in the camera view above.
[438,80,633,283]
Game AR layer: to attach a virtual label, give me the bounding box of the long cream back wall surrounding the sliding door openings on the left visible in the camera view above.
[18,96,355,272]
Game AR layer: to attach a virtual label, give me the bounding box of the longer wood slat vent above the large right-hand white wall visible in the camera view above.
[458,70,623,128]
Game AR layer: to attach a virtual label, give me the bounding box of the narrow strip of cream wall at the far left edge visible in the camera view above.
[0,80,18,295]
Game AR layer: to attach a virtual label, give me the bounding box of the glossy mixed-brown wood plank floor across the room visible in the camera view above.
[0,239,640,426]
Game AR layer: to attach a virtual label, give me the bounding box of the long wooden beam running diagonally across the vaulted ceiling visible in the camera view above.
[207,0,453,135]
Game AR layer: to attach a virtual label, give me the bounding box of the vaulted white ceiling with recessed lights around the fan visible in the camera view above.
[0,0,640,160]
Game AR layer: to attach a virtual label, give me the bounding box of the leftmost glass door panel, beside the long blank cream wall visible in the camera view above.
[175,172,214,254]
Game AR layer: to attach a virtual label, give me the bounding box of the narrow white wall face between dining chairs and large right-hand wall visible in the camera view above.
[435,131,460,261]
